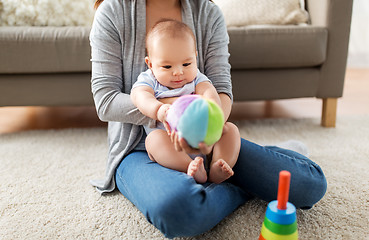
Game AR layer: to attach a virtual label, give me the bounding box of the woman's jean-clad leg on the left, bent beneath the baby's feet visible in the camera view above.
[115,151,247,238]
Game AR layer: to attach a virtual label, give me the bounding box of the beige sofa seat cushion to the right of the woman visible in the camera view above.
[228,25,328,69]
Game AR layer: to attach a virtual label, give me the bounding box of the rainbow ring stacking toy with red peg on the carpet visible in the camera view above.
[259,171,298,240]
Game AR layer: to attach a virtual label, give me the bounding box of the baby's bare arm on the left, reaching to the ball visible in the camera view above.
[131,86,169,122]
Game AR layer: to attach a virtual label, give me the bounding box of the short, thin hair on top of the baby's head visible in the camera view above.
[146,19,196,53]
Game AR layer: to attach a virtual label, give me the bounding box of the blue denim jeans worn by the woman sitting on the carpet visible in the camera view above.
[115,139,327,238]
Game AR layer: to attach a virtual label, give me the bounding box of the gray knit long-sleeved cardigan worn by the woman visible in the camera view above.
[90,0,232,193]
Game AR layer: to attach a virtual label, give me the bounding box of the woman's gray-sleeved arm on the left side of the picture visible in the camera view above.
[90,4,155,125]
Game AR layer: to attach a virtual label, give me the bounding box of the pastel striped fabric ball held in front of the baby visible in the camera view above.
[167,95,224,148]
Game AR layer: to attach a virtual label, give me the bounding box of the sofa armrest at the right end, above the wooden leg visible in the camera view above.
[306,0,353,98]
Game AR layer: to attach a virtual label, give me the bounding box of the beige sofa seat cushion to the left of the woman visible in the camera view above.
[0,27,91,73]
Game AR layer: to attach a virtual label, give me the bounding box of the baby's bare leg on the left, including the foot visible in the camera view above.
[145,130,207,183]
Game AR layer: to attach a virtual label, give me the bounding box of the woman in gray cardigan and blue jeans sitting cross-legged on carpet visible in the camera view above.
[90,0,326,238]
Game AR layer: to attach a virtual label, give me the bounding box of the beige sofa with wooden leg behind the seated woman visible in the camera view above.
[0,0,353,127]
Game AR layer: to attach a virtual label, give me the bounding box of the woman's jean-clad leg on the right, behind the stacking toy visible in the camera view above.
[230,139,327,209]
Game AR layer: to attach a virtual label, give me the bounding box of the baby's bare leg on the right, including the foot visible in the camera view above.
[209,122,241,183]
